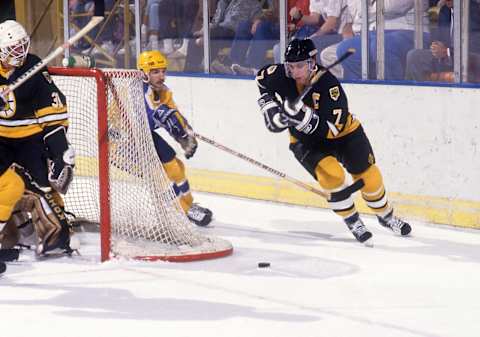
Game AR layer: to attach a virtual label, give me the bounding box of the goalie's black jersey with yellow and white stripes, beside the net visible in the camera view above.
[0,54,68,138]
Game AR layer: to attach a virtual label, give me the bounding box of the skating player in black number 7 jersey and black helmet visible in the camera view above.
[256,39,411,244]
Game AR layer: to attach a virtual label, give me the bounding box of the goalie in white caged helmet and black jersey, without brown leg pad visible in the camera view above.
[0,20,75,254]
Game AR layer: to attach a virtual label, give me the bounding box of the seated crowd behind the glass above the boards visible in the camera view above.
[69,0,480,82]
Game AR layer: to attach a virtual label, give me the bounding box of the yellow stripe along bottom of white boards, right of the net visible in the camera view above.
[187,168,480,229]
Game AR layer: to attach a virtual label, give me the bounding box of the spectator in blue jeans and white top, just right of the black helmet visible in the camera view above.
[337,0,430,80]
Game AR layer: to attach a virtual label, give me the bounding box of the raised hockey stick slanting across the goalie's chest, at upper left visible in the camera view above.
[2,0,105,96]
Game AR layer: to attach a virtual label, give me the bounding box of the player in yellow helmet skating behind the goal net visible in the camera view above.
[137,50,212,226]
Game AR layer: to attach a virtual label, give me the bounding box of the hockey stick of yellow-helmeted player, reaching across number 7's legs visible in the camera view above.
[194,132,364,201]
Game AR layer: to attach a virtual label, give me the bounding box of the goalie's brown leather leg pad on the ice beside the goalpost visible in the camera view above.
[0,166,73,255]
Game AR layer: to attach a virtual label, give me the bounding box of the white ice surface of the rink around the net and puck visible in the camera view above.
[0,194,480,337]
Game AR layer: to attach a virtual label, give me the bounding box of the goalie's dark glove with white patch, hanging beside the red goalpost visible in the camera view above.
[43,126,75,194]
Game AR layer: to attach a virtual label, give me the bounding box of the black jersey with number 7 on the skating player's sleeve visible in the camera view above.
[256,64,360,145]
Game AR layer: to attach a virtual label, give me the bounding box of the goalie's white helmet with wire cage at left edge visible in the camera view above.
[0,20,30,67]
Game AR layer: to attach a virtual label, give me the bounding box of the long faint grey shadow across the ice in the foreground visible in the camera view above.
[0,280,322,322]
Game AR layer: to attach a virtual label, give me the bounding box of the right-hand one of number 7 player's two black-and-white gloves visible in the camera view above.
[283,99,320,134]
